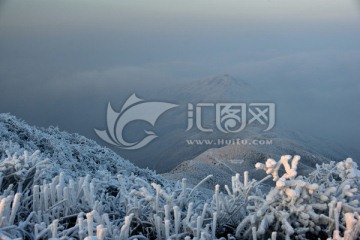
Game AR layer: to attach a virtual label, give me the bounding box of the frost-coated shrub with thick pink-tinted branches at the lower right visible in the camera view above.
[236,155,360,239]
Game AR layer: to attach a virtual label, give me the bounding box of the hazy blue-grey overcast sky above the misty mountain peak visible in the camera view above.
[0,0,360,162]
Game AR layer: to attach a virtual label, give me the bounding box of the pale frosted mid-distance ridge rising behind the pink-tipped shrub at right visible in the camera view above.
[162,127,349,188]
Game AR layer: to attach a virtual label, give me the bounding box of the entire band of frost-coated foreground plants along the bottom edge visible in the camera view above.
[0,151,360,239]
